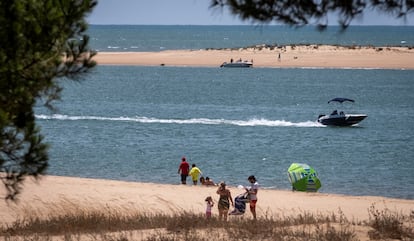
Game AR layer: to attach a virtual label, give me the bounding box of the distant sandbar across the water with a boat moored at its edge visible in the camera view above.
[95,45,414,69]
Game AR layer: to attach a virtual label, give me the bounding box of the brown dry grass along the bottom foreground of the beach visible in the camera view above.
[0,203,414,241]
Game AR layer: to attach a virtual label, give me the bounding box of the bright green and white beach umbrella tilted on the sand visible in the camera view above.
[288,163,322,192]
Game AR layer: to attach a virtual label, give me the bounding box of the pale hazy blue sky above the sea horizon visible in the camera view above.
[87,0,414,25]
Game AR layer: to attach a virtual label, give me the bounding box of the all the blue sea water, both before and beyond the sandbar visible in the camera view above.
[36,26,414,199]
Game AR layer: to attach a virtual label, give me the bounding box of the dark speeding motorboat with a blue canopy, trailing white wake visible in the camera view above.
[318,98,367,126]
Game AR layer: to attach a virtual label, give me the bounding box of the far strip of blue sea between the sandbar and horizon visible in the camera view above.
[89,25,414,51]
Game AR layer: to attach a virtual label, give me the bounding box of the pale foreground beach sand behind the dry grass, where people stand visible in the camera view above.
[0,175,414,225]
